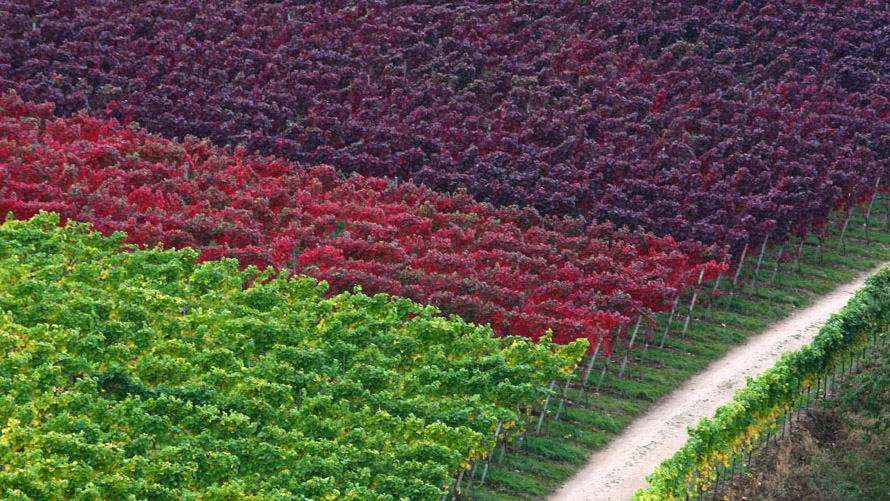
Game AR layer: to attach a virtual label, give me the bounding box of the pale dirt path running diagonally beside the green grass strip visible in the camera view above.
[549,268,878,501]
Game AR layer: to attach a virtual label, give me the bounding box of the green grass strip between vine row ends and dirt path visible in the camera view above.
[469,204,890,501]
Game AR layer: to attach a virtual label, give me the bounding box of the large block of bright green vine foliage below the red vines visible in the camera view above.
[0,213,587,500]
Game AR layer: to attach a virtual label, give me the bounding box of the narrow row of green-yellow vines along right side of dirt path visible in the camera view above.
[634,268,890,501]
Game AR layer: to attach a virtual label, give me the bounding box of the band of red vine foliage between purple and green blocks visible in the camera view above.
[0,96,716,346]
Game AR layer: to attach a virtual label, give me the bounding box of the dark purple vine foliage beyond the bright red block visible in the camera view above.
[0,0,890,250]
